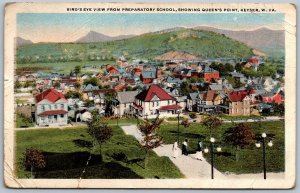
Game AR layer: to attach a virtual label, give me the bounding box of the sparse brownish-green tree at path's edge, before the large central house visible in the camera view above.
[138,115,163,167]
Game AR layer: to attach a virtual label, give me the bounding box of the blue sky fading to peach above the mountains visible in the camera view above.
[17,13,284,43]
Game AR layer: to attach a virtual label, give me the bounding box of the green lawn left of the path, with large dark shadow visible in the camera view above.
[15,126,183,179]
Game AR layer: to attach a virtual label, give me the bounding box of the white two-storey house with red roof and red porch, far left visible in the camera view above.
[35,89,68,126]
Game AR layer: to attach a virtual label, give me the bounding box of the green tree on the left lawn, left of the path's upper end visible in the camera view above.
[87,112,112,158]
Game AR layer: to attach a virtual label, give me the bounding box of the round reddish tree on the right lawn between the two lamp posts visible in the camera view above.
[223,123,254,161]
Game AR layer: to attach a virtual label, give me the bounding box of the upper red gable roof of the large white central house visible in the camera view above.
[136,84,175,102]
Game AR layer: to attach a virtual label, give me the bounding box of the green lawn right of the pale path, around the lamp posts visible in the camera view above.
[158,121,284,174]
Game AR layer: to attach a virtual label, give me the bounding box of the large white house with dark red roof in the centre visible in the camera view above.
[131,84,182,118]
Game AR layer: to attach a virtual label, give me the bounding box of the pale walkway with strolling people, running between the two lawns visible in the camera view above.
[121,125,284,179]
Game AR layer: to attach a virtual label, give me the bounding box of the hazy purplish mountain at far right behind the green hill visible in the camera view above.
[195,26,285,55]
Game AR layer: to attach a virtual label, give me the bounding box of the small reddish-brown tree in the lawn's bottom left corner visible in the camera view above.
[23,147,46,178]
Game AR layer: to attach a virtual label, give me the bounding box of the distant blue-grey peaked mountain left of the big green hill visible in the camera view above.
[75,31,134,43]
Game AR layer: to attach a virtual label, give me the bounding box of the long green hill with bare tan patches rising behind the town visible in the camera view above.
[17,29,253,63]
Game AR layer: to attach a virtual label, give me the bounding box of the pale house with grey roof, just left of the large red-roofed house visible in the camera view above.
[113,91,138,117]
